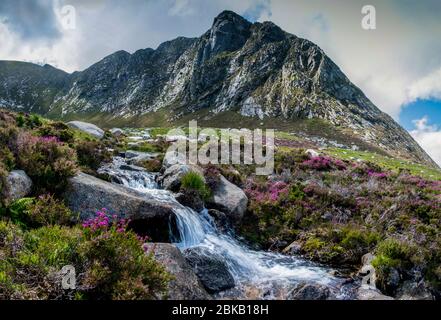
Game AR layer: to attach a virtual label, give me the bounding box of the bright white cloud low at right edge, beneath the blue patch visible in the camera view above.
[410,116,441,166]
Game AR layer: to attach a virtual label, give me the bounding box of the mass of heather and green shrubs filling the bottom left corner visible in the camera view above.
[0,210,170,300]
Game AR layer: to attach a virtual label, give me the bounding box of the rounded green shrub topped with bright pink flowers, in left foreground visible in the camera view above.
[79,210,170,299]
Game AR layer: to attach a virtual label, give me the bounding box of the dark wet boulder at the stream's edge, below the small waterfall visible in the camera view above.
[184,247,235,293]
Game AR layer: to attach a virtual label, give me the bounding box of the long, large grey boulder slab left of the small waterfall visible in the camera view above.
[64,173,176,242]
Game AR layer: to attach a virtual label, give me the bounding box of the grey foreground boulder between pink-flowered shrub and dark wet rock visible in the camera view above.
[147,243,211,300]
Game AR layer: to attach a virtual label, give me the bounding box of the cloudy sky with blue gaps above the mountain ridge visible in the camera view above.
[0,0,441,164]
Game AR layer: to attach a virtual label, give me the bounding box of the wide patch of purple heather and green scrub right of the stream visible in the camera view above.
[239,149,441,294]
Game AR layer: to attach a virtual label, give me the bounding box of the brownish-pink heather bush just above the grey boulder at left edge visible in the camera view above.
[16,133,77,192]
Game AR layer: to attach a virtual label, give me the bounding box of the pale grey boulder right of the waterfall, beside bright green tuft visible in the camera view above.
[207,175,248,224]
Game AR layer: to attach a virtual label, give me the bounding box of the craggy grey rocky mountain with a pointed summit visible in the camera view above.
[0,11,436,166]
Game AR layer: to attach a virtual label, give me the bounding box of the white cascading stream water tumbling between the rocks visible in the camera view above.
[100,157,354,299]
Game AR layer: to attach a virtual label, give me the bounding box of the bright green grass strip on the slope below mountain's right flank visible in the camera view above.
[325,148,441,180]
